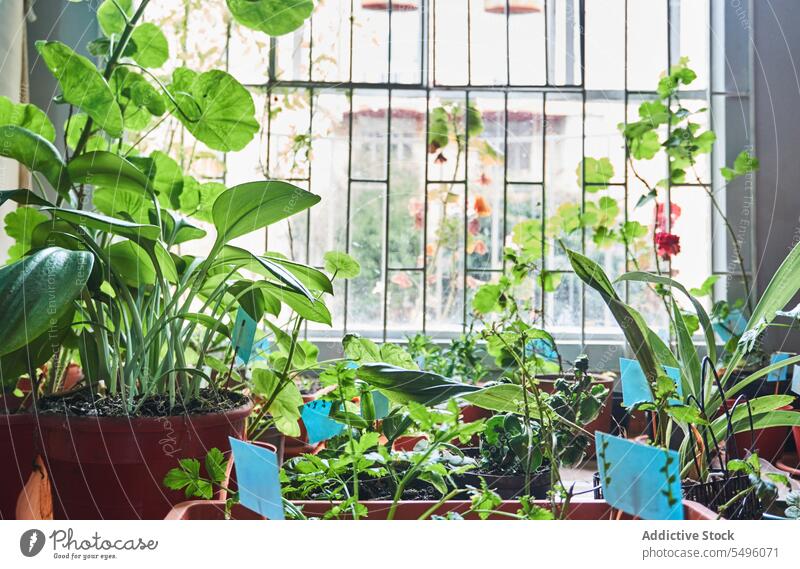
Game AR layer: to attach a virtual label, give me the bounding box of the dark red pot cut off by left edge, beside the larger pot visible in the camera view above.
[0,413,36,520]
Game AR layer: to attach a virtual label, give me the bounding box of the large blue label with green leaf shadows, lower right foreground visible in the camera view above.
[595,431,683,520]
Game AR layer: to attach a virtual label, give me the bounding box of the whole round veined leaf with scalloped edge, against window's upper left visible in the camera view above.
[169,67,259,152]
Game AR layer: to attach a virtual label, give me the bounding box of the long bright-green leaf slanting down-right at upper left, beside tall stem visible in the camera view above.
[36,41,122,138]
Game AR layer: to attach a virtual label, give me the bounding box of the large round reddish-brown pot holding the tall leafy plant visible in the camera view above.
[38,403,253,519]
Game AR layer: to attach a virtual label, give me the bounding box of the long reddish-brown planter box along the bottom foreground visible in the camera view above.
[165,500,717,521]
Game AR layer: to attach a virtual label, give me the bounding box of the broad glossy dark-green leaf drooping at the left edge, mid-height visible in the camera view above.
[0,247,94,355]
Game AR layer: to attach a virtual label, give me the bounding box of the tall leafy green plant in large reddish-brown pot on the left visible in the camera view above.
[0,0,324,518]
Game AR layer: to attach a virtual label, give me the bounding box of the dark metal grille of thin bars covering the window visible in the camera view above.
[158,0,747,343]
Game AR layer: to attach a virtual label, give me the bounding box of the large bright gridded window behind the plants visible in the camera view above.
[139,0,749,342]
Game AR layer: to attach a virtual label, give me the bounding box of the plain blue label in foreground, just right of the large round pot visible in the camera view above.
[228,437,285,520]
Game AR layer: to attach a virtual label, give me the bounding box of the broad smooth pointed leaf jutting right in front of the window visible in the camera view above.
[212,181,320,243]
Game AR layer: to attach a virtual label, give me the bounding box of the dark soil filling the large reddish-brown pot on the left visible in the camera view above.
[39,389,247,417]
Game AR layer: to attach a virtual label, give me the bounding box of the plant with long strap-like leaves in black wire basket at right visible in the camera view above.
[565,241,800,516]
